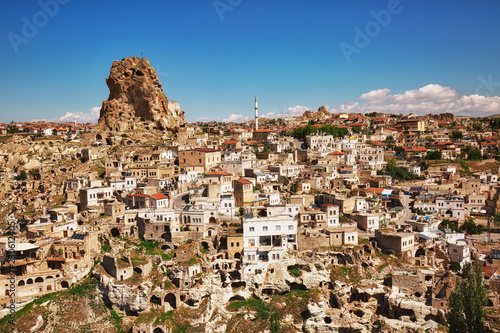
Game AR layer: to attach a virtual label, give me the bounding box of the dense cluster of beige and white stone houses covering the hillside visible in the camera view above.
[0,114,500,308]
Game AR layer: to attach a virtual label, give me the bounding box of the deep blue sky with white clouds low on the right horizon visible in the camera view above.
[0,0,500,122]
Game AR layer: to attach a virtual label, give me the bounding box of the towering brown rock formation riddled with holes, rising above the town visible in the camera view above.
[99,56,186,132]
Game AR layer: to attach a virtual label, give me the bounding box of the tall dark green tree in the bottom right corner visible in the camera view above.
[446,263,488,333]
